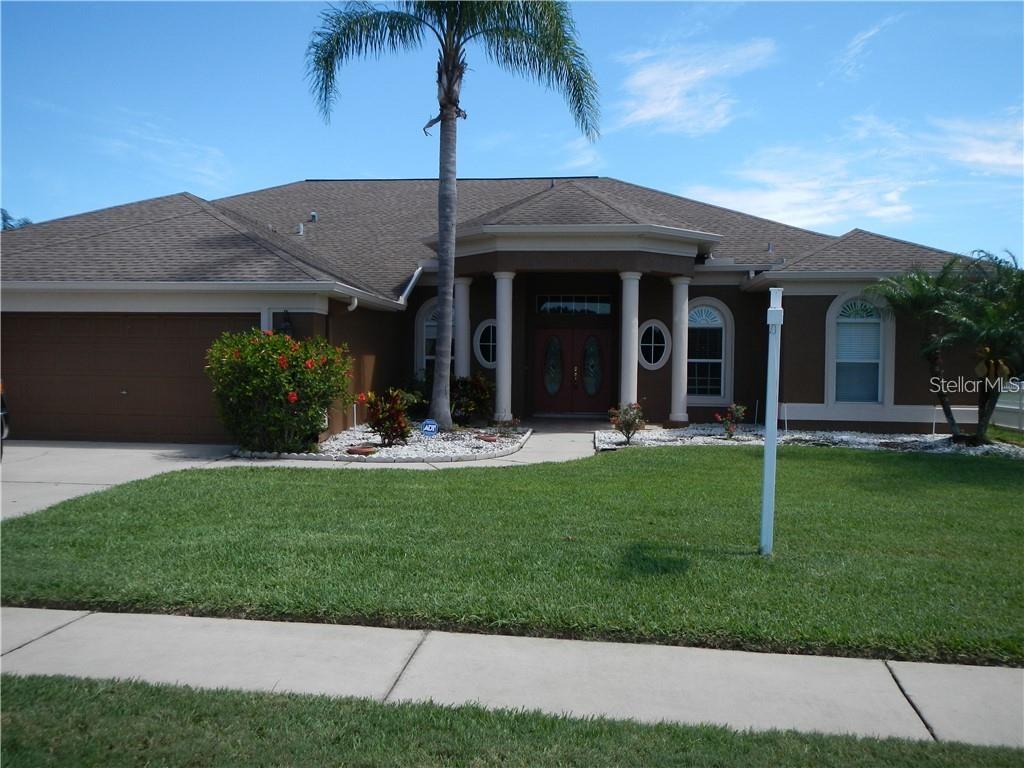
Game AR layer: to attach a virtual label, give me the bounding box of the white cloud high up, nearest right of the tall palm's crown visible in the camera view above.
[618,39,775,136]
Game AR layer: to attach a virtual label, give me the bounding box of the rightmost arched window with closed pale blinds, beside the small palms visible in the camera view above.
[836,299,882,402]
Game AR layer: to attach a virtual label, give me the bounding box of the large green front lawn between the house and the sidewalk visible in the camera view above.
[0,446,1024,665]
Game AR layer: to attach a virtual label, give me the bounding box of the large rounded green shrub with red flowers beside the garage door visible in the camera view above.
[206,329,352,453]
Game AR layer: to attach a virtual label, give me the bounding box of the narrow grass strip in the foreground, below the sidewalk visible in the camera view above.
[8,676,1020,768]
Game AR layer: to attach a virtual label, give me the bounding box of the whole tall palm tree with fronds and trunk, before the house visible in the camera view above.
[306,0,598,429]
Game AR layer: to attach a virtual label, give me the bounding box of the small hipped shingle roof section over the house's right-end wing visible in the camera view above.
[778,229,957,272]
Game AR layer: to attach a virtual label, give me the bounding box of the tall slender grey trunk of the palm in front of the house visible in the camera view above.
[430,105,458,429]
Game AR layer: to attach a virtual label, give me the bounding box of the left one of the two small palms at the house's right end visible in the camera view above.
[867,258,964,440]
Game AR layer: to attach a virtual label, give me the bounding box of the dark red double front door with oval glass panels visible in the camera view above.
[534,328,611,414]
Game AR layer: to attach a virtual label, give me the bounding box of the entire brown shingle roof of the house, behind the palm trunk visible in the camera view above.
[2,176,951,299]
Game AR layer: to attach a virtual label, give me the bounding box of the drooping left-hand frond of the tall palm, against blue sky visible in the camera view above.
[306,2,428,121]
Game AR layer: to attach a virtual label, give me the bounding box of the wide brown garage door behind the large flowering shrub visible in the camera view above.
[0,312,259,442]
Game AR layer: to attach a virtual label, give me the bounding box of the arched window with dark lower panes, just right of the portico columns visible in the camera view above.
[686,297,733,406]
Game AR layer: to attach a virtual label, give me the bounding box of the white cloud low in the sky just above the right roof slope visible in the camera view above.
[683,146,923,227]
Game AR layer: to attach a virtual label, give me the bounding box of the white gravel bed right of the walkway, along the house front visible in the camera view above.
[594,424,1024,459]
